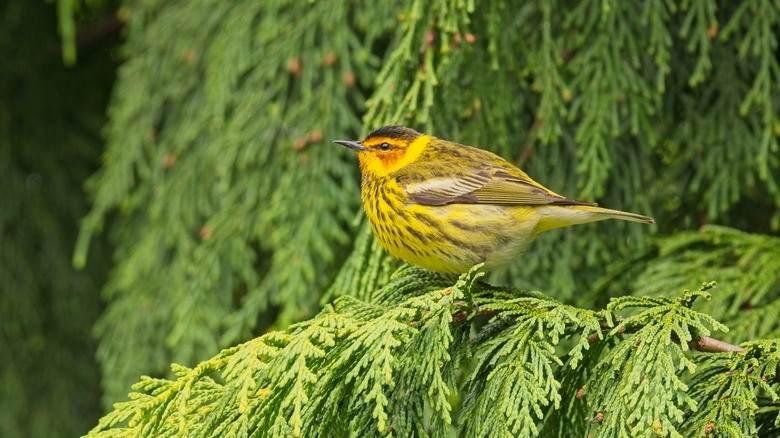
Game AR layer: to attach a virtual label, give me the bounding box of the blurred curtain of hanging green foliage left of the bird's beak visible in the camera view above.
[75,1,371,400]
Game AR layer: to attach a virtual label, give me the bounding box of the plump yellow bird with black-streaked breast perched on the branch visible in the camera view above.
[334,125,654,274]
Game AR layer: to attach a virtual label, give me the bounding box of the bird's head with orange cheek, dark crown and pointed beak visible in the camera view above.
[334,126,433,177]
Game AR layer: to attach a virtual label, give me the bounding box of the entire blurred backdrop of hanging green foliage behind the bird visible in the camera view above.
[64,0,780,412]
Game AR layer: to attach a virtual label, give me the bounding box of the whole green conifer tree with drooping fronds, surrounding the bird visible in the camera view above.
[0,0,780,437]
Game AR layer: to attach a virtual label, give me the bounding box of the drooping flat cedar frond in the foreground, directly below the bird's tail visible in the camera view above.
[461,291,601,436]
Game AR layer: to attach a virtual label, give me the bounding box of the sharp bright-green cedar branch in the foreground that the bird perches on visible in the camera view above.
[89,268,780,437]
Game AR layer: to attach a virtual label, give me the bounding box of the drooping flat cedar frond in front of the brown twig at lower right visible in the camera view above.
[585,284,727,436]
